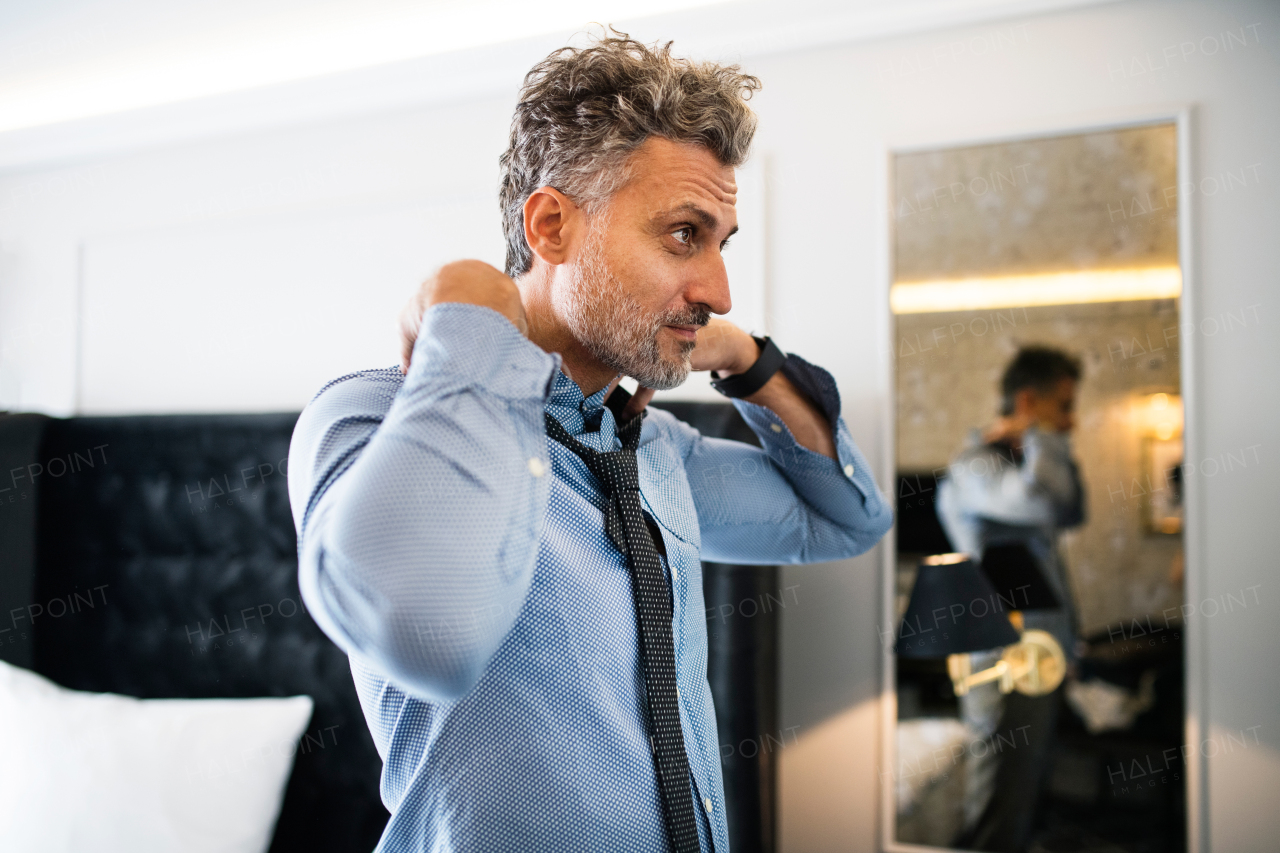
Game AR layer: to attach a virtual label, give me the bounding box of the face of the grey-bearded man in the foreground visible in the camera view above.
[556,137,737,389]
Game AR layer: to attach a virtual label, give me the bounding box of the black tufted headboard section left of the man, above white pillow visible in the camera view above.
[9,414,387,853]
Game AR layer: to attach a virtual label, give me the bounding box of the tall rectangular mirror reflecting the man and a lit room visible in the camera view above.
[882,123,1187,853]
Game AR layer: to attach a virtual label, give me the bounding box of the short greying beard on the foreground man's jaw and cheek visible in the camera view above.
[557,223,710,391]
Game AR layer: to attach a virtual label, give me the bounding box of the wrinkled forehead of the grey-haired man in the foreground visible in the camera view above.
[620,137,737,216]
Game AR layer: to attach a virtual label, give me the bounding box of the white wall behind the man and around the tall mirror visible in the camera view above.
[0,1,1280,853]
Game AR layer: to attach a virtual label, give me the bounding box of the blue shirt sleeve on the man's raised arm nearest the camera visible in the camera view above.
[289,304,558,699]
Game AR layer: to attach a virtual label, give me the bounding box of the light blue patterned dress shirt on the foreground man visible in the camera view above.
[289,304,892,853]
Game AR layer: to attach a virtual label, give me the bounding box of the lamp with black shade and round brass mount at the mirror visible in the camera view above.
[893,553,1066,695]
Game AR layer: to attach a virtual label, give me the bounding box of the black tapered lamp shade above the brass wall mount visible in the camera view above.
[893,555,1019,657]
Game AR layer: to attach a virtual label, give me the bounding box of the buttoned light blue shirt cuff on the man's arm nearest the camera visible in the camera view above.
[404,302,561,400]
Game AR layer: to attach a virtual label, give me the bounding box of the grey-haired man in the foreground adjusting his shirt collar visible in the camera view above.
[289,37,892,853]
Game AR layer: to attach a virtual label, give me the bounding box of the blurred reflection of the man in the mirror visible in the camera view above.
[937,346,1084,850]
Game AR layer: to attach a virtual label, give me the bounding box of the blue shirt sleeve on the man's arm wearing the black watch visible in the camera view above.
[685,355,893,564]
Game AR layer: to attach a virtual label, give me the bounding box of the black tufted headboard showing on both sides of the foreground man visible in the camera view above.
[0,403,780,853]
